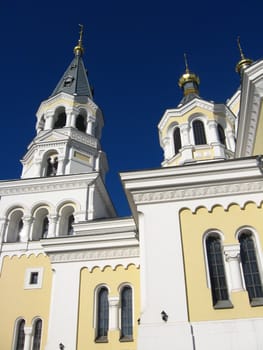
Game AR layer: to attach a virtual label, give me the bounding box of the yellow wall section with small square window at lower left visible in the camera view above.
[0,254,52,350]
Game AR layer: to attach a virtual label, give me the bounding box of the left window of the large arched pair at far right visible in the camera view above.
[206,235,232,309]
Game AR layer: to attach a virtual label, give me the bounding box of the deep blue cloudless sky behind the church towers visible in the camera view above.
[0,0,263,216]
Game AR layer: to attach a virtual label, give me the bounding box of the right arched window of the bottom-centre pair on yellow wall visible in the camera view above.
[121,286,133,341]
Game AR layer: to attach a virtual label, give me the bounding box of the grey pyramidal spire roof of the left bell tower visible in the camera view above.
[51,54,93,99]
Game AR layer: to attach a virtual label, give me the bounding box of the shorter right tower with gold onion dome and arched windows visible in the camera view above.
[158,56,236,167]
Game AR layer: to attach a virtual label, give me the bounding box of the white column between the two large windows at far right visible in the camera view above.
[224,244,244,292]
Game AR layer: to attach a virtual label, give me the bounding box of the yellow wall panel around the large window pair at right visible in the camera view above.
[180,203,263,321]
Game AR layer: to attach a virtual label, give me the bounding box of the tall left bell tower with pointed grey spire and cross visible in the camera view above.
[21,25,108,179]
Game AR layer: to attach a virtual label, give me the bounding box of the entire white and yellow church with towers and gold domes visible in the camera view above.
[0,27,263,350]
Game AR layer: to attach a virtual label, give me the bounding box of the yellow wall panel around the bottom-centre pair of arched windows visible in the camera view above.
[77,265,140,350]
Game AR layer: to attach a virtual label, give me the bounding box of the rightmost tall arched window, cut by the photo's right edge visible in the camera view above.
[239,231,263,306]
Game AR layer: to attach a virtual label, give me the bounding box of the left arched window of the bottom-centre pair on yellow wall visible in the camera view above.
[96,287,109,342]
